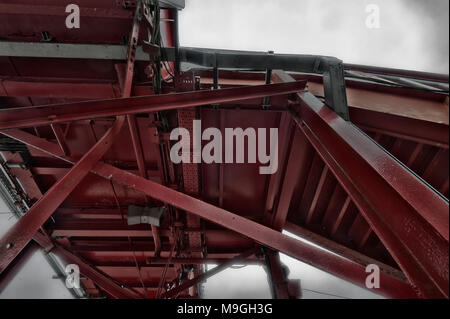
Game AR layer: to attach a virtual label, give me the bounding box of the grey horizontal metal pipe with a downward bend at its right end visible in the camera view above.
[0,42,349,120]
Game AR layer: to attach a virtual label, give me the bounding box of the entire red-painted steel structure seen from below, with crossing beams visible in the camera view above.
[0,0,449,298]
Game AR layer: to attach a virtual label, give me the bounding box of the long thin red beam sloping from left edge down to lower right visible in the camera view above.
[2,130,414,298]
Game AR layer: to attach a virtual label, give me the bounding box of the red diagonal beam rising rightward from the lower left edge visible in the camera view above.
[0,117,125,273]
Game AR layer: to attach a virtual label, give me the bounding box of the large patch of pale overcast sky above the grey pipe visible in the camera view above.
[180,0,449,74]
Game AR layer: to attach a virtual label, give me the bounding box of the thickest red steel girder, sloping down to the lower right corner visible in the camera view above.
[294,92,449,298]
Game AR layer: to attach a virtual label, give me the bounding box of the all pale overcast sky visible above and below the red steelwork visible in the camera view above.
[0,0,449,298]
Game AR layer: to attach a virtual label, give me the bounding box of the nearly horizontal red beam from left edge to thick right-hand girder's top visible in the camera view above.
[0,81,305,130]
